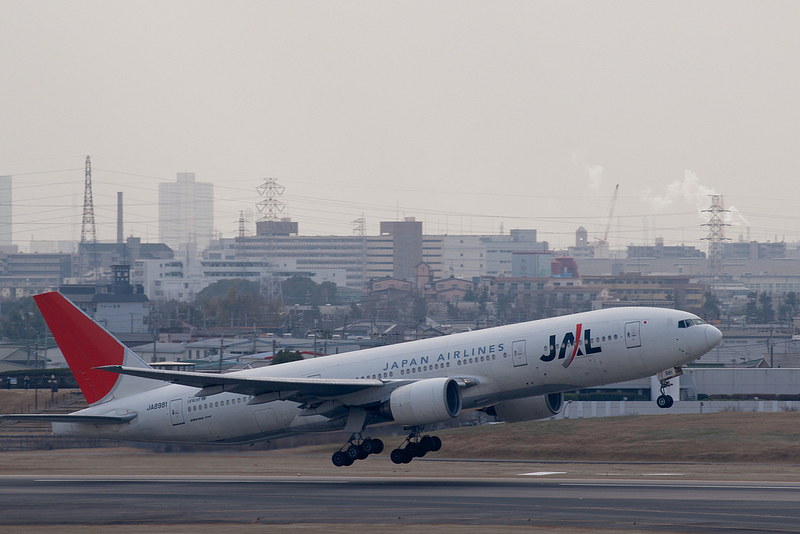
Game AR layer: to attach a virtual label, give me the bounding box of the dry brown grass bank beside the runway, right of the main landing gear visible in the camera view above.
[441,412,800,463]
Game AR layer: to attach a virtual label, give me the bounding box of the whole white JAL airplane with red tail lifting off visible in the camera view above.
[2,292,722,466]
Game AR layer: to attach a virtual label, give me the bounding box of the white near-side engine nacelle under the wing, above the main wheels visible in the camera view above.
[381,378,461,426]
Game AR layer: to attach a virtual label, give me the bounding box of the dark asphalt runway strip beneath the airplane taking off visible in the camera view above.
[0,475,800,533]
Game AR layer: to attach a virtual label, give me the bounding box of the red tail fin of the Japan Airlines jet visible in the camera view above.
[33,292,125,404]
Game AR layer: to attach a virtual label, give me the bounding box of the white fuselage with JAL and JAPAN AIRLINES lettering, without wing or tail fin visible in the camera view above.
[53,307,720,443]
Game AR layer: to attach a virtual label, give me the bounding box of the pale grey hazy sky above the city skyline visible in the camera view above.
[0,0,800,249]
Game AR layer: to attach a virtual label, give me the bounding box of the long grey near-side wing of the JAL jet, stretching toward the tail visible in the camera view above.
[96,365,384,397]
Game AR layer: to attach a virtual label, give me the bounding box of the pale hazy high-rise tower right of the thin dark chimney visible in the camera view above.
[158,172,214,256]
